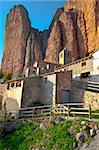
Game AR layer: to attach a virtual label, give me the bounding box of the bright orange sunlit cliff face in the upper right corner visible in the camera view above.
[64,0,99,54]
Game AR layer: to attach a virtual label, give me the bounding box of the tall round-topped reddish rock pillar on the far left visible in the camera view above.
[2,6,31,77]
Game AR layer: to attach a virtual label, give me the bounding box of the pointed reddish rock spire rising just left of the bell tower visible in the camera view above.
[46,20,62,63]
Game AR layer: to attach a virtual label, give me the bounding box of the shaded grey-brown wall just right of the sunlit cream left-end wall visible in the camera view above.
[22,77,41,107]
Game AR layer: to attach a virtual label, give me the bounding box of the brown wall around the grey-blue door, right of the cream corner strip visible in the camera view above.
[56,72,71,103]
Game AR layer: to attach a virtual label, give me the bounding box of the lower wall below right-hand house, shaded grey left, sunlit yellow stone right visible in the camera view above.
[70,80,99,109]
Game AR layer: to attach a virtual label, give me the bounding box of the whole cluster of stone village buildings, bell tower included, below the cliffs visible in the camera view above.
[2,49,99,113]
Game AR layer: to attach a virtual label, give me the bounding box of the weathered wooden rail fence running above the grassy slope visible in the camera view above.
[19,103,94,118]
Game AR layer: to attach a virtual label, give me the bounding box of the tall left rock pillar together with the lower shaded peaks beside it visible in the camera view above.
[2,6,49,77]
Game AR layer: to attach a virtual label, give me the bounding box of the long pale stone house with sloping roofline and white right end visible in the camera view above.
[54,50,99,82]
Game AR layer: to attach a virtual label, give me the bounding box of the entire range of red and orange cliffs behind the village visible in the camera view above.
[2,0,99,77]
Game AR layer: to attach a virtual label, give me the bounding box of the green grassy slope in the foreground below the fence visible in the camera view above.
[0,120,82,150]
